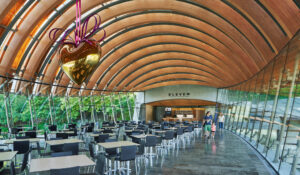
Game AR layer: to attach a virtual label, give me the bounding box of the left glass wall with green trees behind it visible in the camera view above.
[0,80,135,132]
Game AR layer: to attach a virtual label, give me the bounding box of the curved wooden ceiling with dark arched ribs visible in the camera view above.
[0,0,300,94]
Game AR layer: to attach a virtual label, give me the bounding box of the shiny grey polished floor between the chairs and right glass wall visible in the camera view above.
[131,131,274,175]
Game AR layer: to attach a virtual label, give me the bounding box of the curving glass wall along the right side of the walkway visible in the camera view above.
[217,32,300,174]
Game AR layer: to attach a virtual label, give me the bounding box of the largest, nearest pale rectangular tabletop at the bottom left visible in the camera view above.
[29,155,95,173]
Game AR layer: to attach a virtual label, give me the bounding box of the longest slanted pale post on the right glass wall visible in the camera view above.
[273,55,300,163]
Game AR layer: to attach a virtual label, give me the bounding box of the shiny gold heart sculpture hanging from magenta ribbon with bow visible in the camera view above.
[49,0,106,85]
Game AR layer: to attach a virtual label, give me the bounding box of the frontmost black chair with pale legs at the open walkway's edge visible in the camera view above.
[116,146,137,174]
